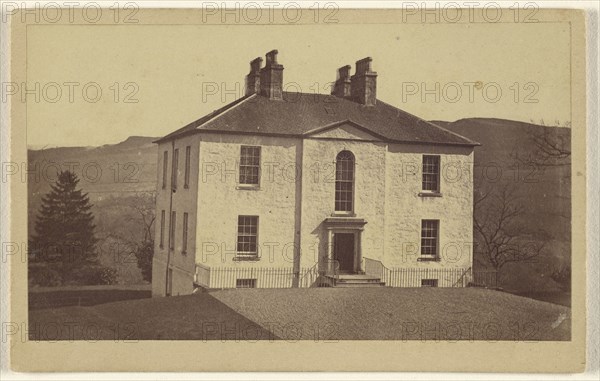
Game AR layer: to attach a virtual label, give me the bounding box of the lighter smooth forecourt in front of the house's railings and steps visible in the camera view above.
[210,287,571,341]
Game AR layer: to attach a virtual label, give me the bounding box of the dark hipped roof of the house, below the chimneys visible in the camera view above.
[156,92,479,146]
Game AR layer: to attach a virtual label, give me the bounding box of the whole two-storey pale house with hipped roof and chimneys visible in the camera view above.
[153,51,477,296]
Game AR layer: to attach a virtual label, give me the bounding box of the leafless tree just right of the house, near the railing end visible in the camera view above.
[473,184,544,271]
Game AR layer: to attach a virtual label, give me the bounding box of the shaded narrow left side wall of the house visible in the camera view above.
[152,135,199,296]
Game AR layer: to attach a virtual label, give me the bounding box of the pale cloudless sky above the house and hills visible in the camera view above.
[26,23,571,148]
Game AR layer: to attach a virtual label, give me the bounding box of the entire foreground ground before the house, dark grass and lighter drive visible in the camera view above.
[30,287,571,341]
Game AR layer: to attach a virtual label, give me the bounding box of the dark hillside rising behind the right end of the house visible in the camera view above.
[433,118,571,290]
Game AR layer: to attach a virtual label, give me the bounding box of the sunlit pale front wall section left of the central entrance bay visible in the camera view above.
[195,134,301,287]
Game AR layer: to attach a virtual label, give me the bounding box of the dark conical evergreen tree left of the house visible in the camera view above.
[30,171,97,280]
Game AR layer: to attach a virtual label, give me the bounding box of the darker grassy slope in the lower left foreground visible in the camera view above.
[29,293,276,341]
